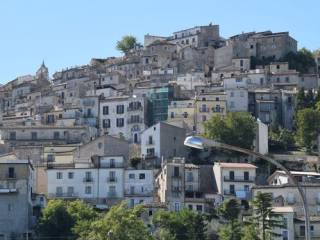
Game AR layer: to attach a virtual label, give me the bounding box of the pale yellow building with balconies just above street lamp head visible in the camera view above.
[195,92,227,134]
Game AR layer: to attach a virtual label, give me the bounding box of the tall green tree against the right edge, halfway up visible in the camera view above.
[296,108,320,150]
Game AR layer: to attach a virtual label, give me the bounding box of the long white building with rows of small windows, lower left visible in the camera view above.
[47,156,124,207]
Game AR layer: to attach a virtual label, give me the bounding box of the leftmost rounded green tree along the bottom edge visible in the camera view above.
[38,200,75,239]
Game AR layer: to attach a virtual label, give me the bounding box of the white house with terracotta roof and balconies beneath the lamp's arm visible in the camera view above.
[213,163,257,204]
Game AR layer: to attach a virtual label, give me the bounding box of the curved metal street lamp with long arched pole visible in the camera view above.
[184,136,310,240]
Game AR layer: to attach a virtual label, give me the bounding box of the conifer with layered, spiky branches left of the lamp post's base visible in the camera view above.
[252,192,283,240]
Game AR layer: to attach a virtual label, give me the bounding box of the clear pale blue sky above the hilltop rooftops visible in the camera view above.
[0,0,320,83]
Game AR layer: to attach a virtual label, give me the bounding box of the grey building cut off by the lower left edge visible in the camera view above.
[0,154,34,239]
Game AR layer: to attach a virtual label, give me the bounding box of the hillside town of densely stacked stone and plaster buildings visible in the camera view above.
[0,23,320,240]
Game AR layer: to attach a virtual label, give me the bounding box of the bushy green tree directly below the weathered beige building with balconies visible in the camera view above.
[152,209,206,240]
